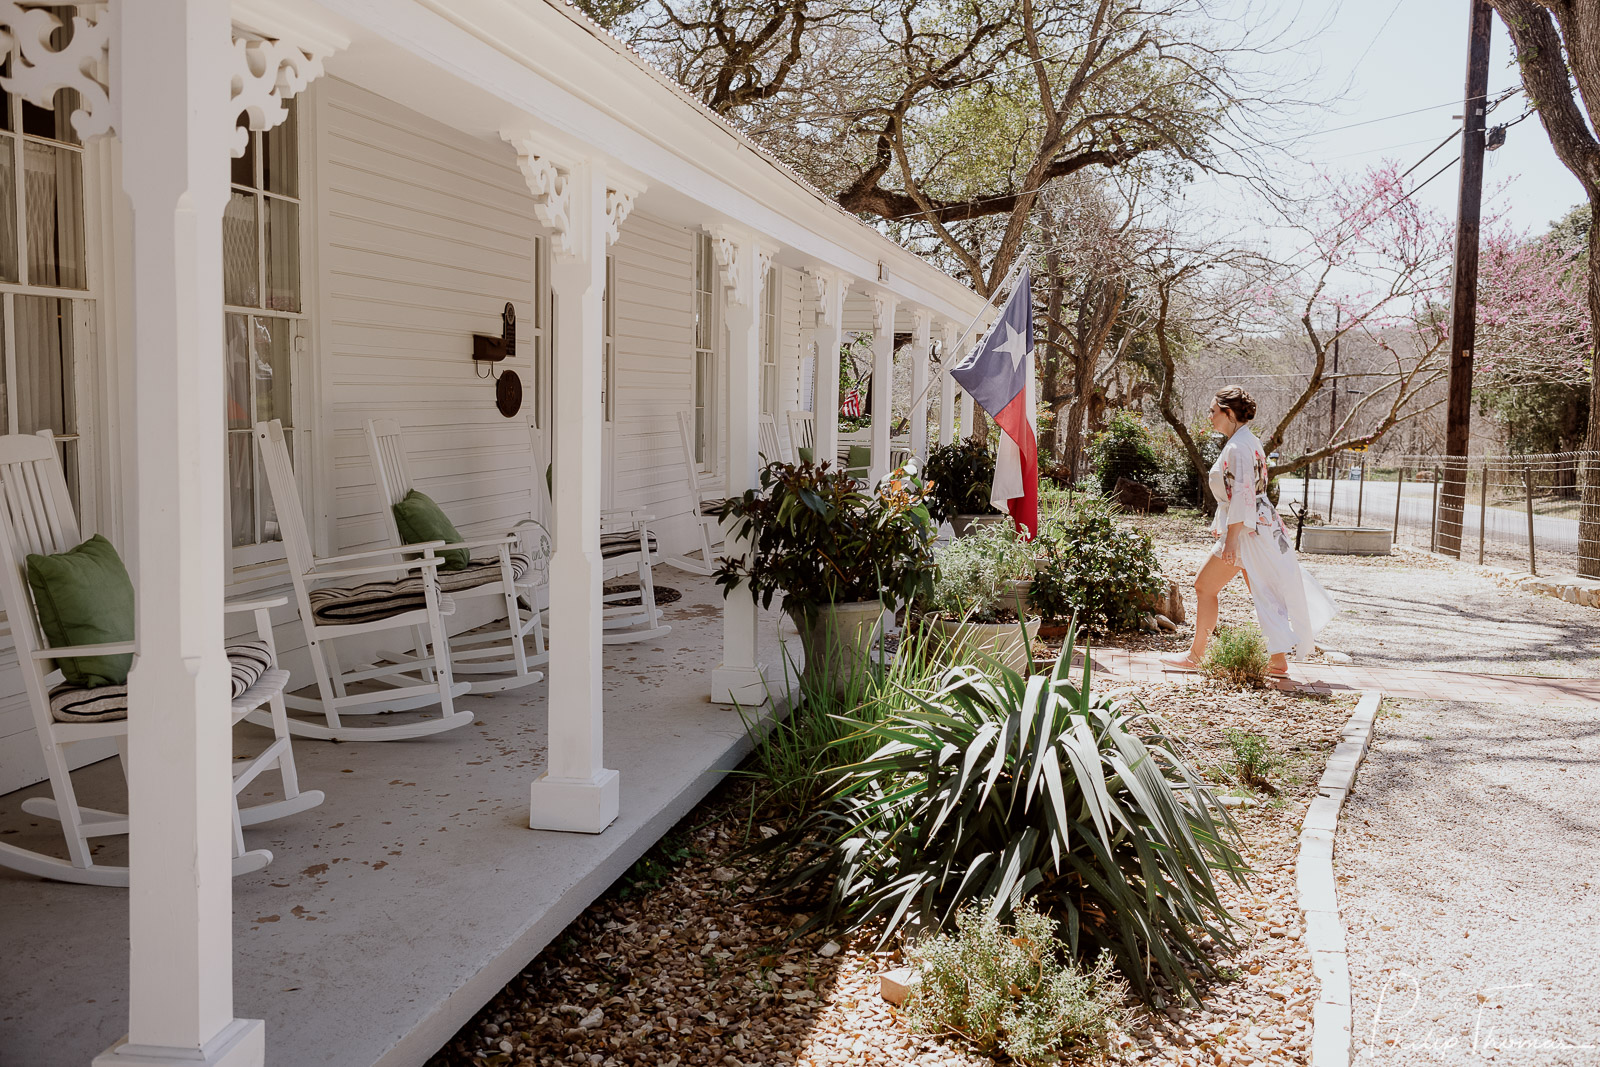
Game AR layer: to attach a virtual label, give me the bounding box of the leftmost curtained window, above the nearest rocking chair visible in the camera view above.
[0,71,91,511]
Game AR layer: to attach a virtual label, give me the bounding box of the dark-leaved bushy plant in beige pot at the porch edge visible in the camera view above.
[706,462,938,694]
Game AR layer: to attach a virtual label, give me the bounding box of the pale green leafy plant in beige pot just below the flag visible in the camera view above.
[920,523,1040,670]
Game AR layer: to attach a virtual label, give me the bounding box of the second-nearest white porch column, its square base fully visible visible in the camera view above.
[507,134,618,833]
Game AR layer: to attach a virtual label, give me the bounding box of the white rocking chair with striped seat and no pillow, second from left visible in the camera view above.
[254,419,472,741]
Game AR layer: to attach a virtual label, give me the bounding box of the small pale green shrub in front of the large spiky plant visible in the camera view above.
[907,901,1126,1067]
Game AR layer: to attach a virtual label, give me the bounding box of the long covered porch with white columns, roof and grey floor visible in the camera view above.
[0,0,984,1067]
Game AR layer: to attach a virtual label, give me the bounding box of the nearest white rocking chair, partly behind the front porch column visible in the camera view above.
[0,430,323,886]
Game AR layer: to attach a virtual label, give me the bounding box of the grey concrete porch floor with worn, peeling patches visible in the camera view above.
[0,568,792,1067]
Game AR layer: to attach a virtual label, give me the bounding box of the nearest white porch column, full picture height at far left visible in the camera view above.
[101,0,266,1067]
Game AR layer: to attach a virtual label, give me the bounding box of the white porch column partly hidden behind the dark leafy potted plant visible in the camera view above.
[710,229,773,707]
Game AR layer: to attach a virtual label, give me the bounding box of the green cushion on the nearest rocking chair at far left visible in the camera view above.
[27,534,133,689]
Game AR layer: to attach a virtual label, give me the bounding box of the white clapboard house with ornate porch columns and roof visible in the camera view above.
[0,0,984,1065]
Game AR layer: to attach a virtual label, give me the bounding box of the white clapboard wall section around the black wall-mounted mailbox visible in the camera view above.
[317,80,539,579]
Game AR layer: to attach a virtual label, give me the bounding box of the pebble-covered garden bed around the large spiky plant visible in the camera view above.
[429,671,1352,1067]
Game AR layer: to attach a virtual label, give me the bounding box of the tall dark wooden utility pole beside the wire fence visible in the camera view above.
[1438,0,1494,558]
